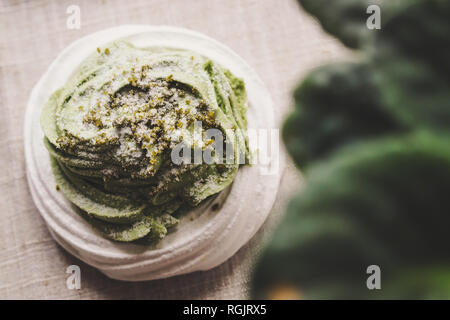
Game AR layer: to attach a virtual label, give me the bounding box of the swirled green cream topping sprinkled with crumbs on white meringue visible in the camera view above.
[41,41,248,244]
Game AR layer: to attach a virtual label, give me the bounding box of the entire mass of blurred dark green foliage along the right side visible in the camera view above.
[252,0,450,299]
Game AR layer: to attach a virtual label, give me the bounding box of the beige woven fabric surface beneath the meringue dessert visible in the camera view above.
[0,0,346,299]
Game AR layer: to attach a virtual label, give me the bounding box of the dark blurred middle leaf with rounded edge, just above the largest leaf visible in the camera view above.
[283,63,406,168]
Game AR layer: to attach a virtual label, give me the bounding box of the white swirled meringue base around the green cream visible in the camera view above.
[25,25,283,281]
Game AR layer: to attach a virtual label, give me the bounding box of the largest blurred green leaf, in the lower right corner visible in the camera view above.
[253,133,450,299]
